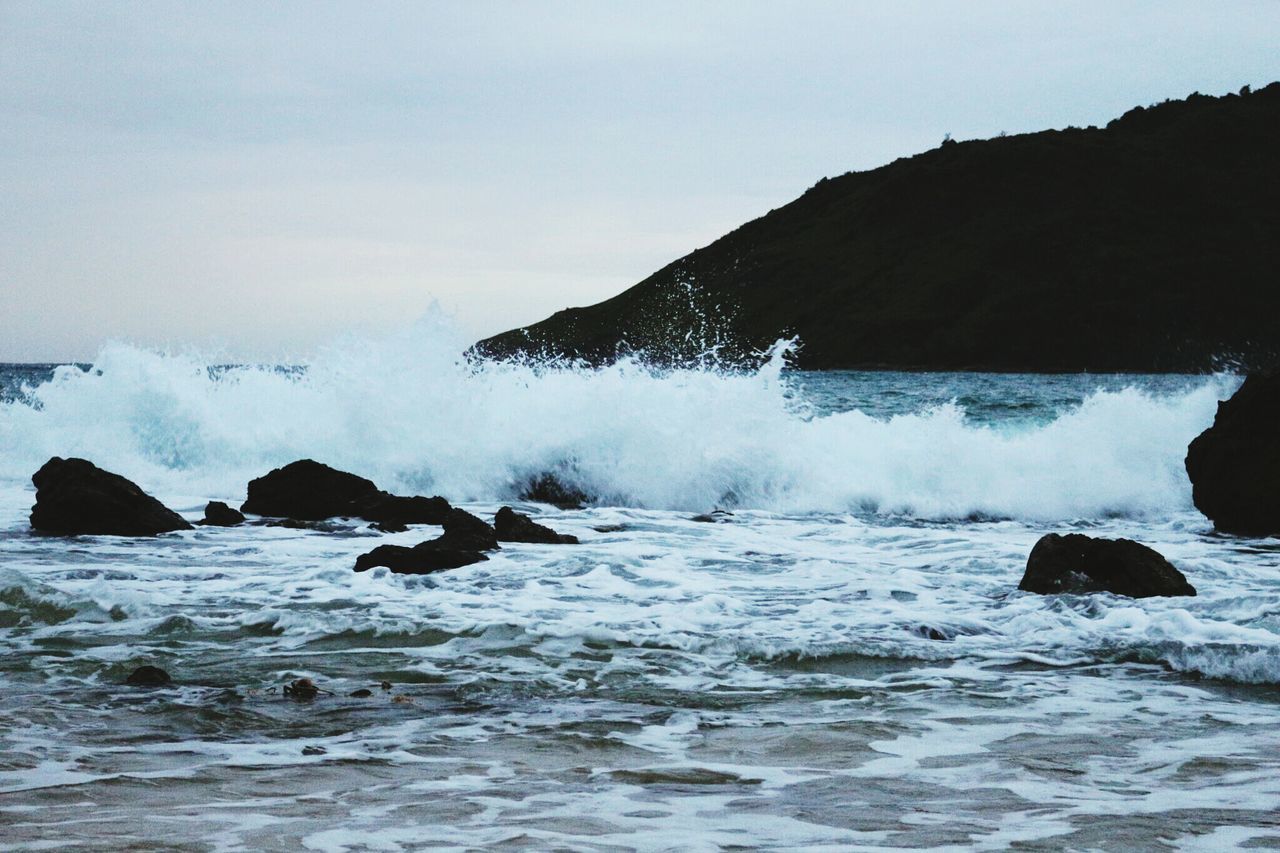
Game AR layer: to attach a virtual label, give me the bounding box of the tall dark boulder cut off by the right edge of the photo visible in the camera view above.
[1187,373,1280,535]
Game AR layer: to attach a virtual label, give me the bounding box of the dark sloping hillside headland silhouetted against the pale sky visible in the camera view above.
[474,83,1280,371]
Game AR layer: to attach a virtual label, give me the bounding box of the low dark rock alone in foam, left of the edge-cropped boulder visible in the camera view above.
[1018,533,1196,598]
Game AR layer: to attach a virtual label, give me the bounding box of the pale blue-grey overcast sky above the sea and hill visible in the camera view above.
[0,0,1280,361]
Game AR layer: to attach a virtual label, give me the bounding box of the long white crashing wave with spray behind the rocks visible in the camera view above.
[0,323,1235,520]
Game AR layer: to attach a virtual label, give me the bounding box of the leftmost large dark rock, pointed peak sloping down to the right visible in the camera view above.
[31,456,191,537]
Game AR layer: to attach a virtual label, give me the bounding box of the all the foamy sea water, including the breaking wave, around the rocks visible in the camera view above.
[0,330,1280,850]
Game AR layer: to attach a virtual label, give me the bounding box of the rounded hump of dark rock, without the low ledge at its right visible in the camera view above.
[241,459,379,521]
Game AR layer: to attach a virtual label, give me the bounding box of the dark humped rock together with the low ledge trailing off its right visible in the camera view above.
[241,459,449,524]
